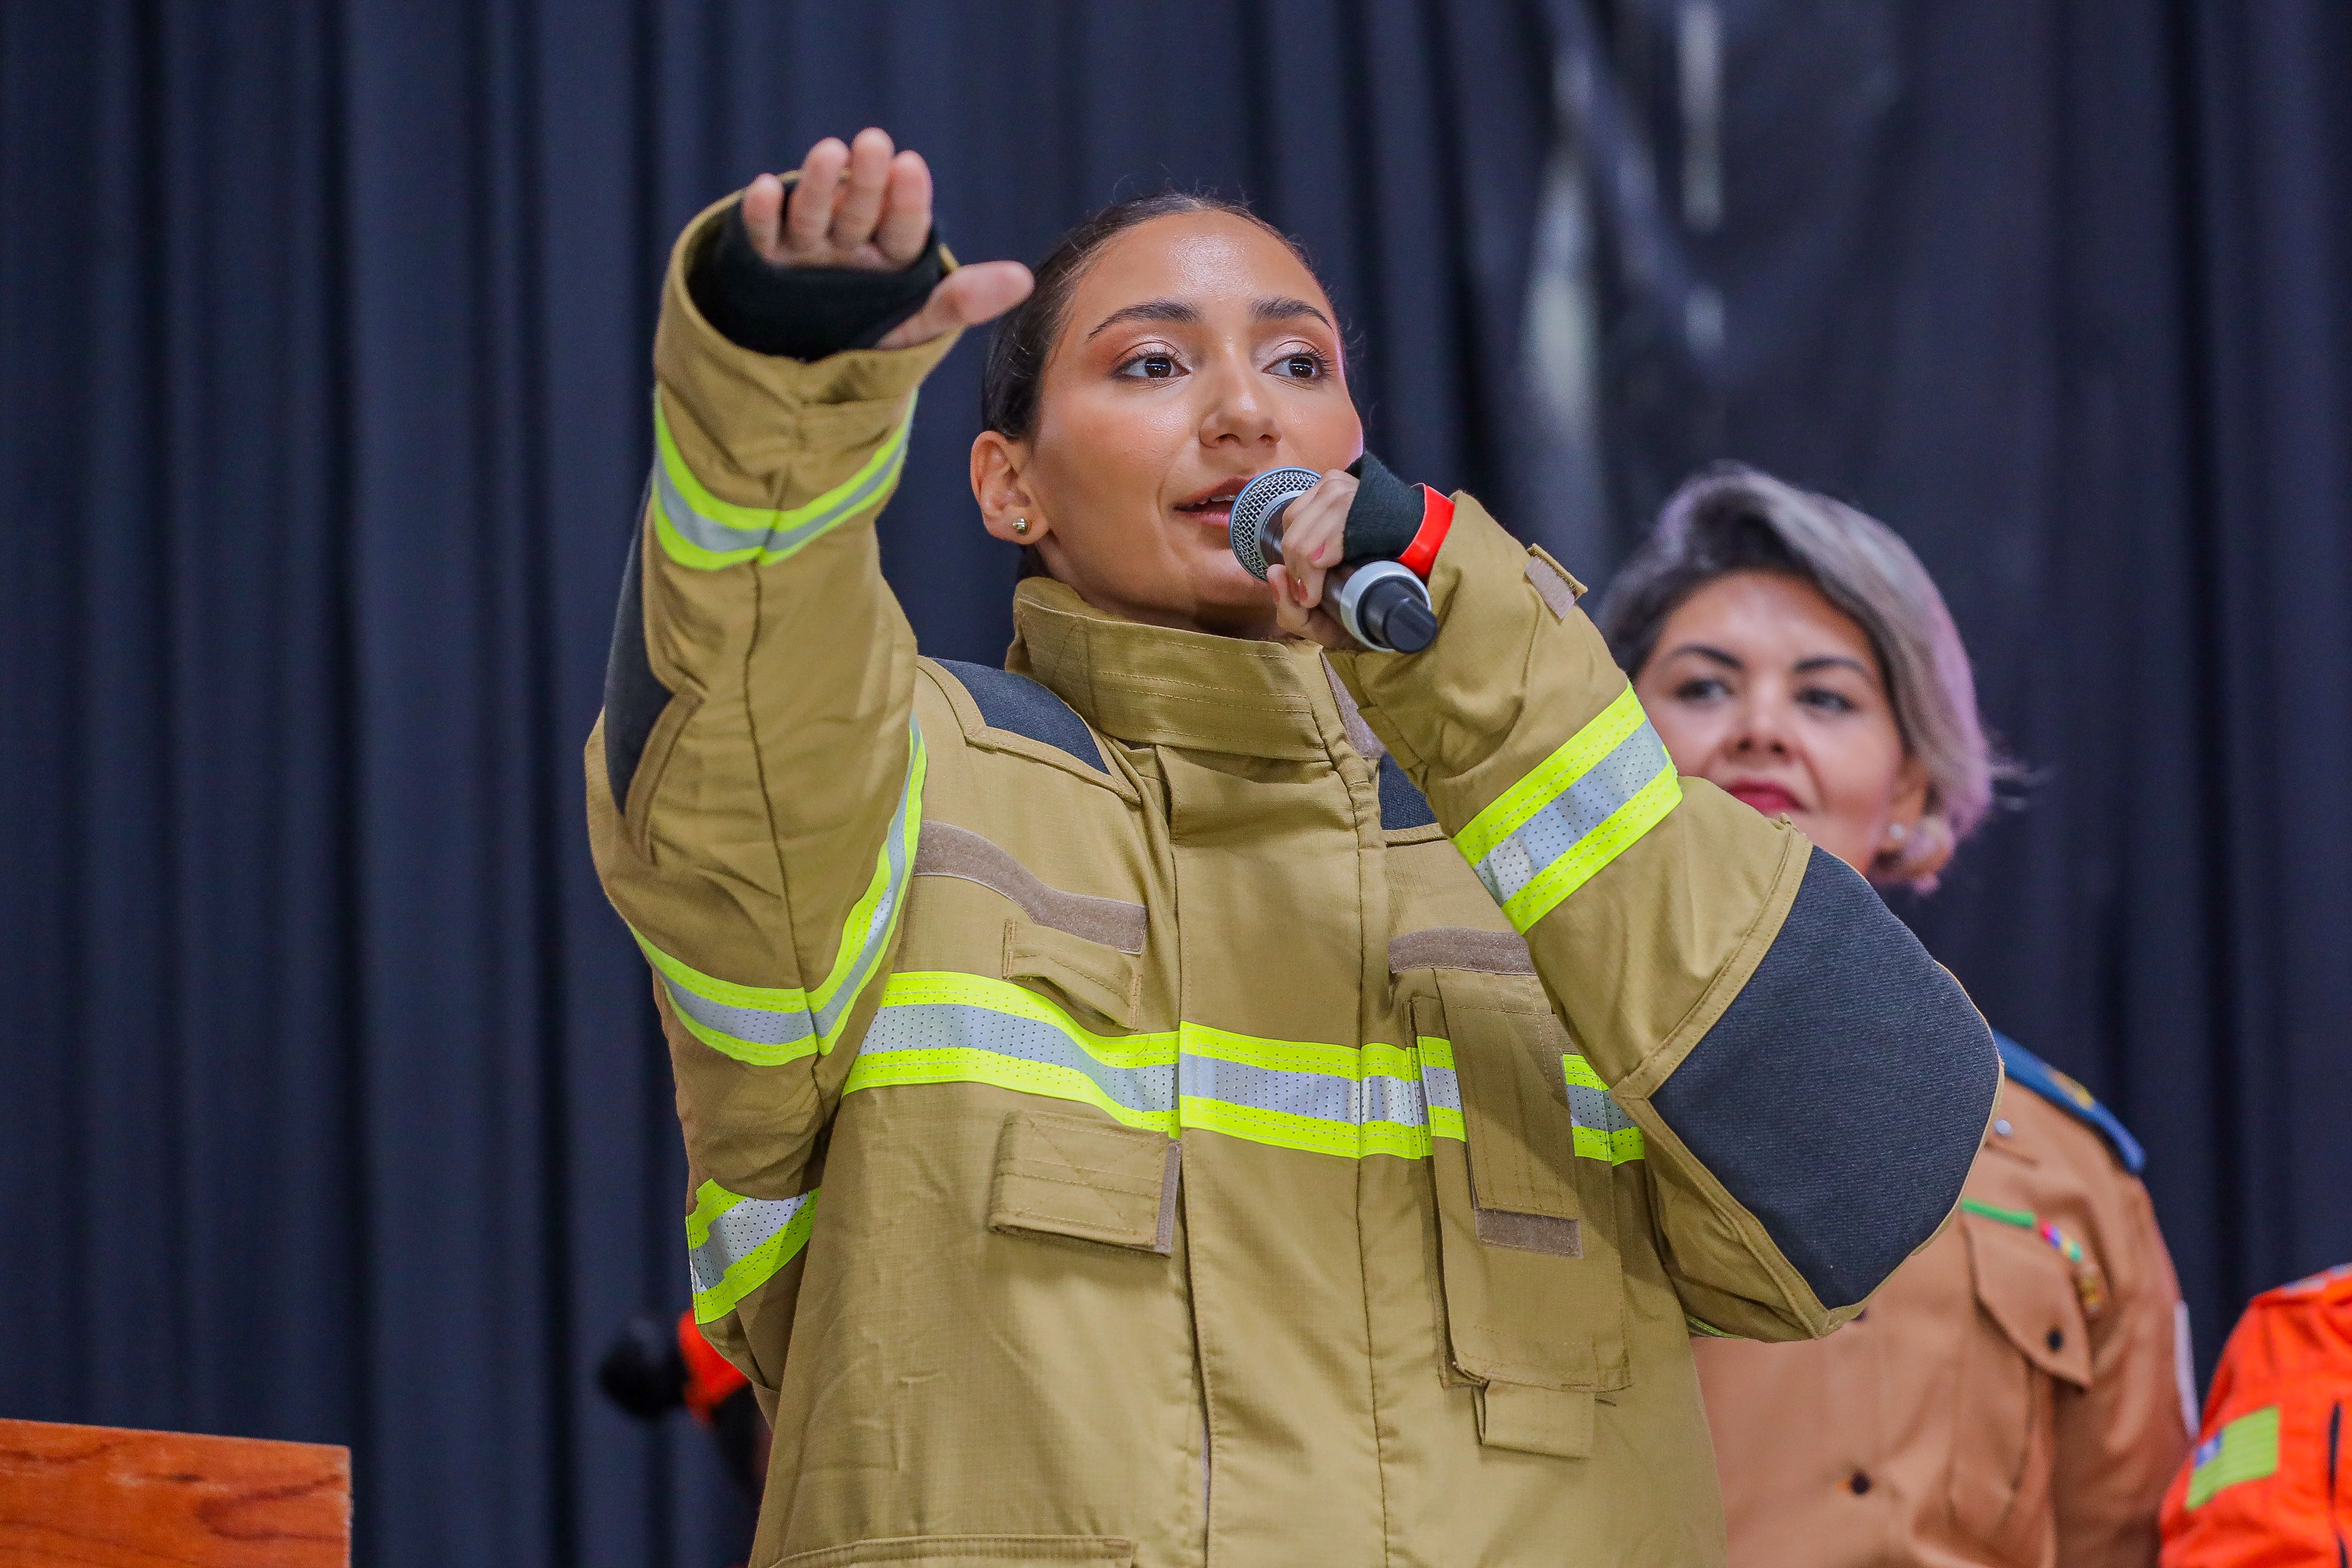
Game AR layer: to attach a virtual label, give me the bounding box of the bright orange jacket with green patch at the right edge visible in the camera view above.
[2164,1263,2352,1568]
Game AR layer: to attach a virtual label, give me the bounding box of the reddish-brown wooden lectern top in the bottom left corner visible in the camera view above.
[0,1420,350,1568]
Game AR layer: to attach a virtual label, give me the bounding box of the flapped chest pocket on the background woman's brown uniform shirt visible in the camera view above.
[1952,1210,2091,1561]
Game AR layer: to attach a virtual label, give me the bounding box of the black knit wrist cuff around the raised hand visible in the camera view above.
[687,188,948,360]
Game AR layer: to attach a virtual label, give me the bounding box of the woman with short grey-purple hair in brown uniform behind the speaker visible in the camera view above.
[1600,468,2195,1568]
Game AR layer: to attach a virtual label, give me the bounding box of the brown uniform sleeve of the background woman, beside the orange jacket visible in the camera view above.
[2051,1180,2197,1568]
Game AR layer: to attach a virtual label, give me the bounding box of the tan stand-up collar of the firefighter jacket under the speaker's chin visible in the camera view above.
[1004,578,1348,762]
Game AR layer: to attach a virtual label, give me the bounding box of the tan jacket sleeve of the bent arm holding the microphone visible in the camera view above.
[1334,496,1999,1338]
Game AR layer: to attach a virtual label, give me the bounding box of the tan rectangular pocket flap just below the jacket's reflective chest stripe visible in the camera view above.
[988,1110,1183,1255]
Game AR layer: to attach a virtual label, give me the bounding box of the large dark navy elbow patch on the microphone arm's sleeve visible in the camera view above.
[1651,849,1999,1309]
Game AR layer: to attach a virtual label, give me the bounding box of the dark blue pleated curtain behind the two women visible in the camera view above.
[0,0,2352,1568]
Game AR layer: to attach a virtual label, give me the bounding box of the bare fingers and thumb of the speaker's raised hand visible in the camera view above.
[743,127,1035,348]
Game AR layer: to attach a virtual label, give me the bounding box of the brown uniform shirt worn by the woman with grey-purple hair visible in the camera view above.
[1696,1053,2192,1568]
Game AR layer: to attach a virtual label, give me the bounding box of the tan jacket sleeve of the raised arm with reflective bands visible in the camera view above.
[588,198,950,1396]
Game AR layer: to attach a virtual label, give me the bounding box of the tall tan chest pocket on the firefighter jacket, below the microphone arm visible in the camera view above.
[1414,973,1639,1457]
